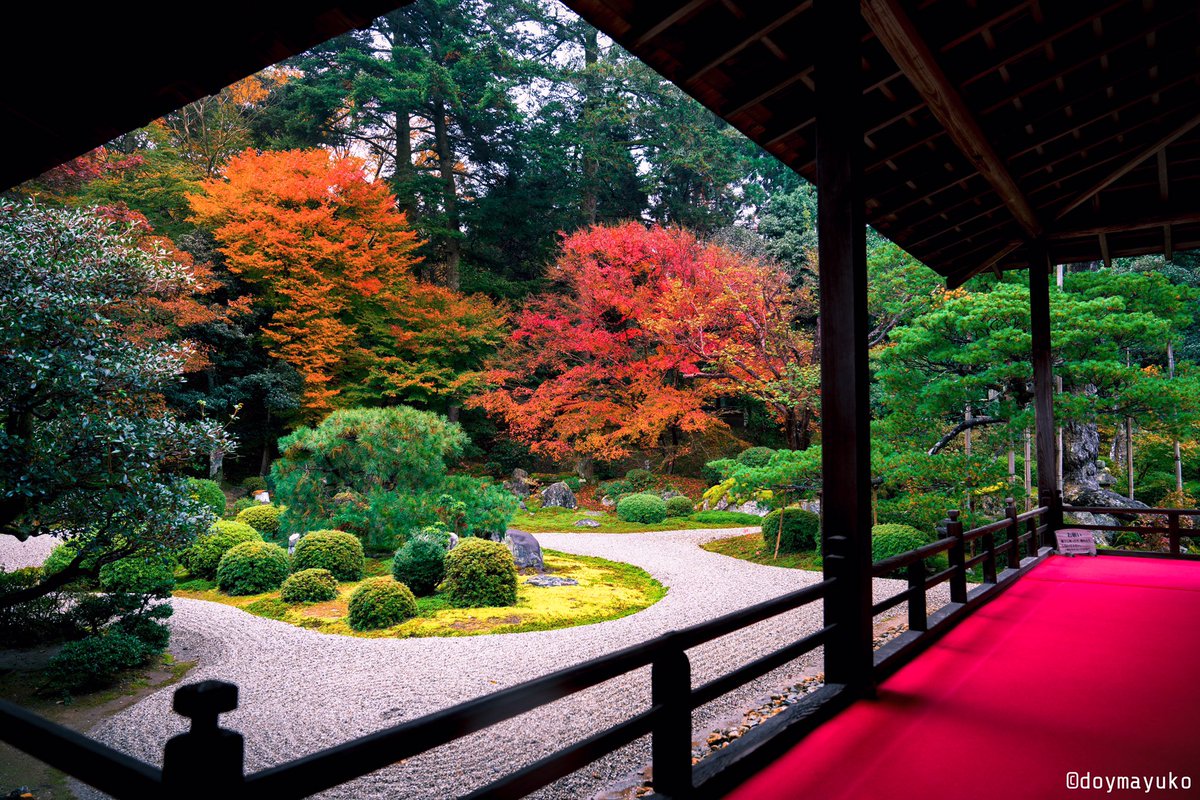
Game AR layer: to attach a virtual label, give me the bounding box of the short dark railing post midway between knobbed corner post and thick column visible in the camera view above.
[650,646,692,798]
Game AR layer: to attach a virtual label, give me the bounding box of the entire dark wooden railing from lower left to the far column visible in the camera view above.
[0,500,1080,800]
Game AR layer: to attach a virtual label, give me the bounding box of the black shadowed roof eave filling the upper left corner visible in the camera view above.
[0,0,412,190]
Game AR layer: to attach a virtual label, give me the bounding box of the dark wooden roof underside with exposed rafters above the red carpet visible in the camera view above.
[565,0,1200,285]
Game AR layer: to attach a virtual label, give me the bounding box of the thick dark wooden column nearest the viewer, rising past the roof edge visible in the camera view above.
[814,0,872,690]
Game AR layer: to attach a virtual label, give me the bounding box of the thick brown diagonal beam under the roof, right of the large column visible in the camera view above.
[864,0,1042,237]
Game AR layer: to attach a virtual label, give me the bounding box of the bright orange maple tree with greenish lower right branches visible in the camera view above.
[188,150,502,422]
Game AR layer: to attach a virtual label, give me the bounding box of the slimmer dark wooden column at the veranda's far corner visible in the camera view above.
[1030,251,1062,527]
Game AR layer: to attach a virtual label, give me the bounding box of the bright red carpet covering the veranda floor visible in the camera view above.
[730,557,1200,800]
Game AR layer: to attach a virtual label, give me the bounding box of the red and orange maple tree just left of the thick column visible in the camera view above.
[472,223,811,470]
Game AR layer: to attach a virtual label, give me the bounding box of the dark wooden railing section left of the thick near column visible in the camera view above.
[0,579,842,800]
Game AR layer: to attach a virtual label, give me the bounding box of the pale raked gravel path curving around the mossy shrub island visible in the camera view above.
[28,529,944,800]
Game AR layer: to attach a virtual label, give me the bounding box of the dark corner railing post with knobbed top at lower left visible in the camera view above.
[162,680,246,800]
